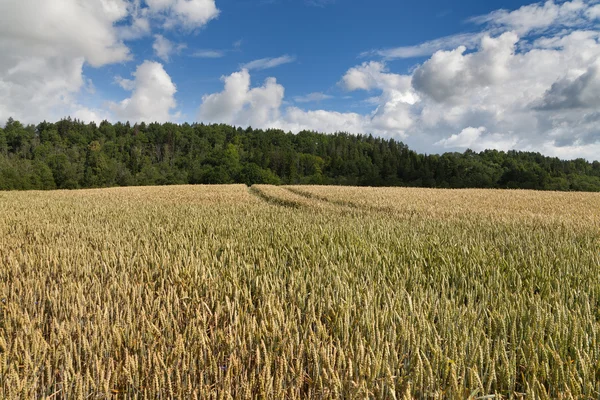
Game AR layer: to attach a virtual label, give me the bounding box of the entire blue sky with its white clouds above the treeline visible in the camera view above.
[0,0,600,161]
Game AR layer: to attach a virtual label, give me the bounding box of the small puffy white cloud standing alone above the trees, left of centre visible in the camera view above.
[109,61,177,122]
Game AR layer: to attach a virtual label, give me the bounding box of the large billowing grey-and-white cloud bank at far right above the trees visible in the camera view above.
[409,24,600,158]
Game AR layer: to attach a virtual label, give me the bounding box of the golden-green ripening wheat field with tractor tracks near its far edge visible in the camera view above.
[0,185,600,399]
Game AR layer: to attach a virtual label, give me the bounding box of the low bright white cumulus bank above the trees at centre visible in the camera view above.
[198,64,414,137]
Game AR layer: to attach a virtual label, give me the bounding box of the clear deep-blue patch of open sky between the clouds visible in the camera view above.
[90,0,528,117]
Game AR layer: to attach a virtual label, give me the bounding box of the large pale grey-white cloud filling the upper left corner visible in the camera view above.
[0,0,131,124]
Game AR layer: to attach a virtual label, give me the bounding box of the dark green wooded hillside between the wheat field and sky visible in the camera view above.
[0,118,600,191]
